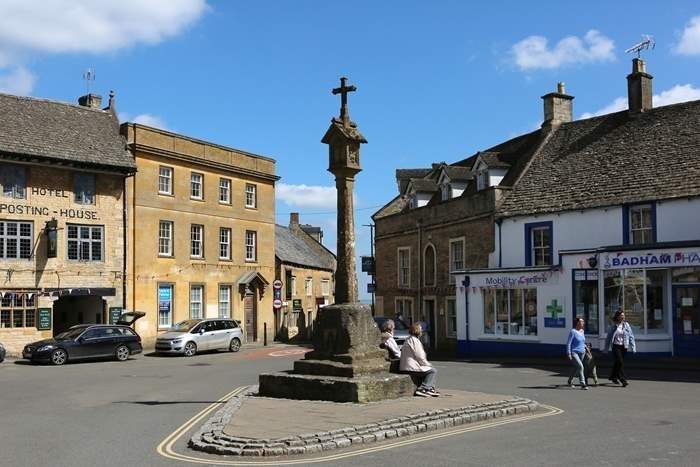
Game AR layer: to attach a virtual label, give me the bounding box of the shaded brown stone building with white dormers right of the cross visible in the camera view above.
[372,113,541,350]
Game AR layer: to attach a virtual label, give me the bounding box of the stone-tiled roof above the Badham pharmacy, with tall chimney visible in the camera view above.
[497,101,700,217]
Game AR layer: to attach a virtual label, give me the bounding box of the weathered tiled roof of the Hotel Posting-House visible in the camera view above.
[0,93,136,172]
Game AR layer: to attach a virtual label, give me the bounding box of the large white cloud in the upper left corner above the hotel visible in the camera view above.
[0,0,207,94]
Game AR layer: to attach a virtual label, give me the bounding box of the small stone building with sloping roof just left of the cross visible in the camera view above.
[275,213,336,340]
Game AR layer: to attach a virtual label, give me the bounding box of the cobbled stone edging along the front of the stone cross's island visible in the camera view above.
[188,386,539,456]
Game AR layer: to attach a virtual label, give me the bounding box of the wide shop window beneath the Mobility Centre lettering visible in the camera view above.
[484,289,537,336]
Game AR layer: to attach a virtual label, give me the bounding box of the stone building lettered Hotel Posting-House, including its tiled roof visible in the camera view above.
[0,90,136,354]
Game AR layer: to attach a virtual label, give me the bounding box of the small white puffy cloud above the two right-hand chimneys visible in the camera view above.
[511,29,615,70]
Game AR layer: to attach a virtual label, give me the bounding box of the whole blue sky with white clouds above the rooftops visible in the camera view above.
[0,0,700,298]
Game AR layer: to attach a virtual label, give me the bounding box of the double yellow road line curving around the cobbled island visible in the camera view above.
[156,394,564,465]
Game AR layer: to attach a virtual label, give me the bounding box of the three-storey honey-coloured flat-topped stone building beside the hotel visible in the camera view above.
[121,123,279,344]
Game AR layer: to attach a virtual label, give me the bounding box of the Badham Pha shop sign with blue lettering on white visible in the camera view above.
[601,249,700,269]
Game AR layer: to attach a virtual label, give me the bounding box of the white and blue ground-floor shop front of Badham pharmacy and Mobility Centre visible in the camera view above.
[457,245,700,357]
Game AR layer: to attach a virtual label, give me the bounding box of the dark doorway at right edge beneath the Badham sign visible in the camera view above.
[673,285,700,357]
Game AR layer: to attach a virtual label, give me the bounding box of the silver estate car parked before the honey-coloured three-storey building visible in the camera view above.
[156,318,243,357]
